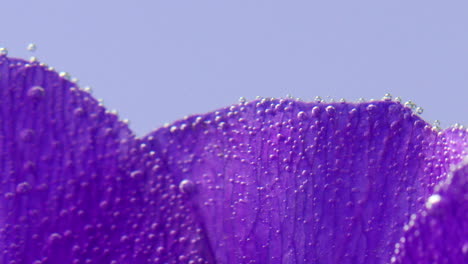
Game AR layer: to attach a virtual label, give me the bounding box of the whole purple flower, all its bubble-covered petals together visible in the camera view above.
[0,56,468,264]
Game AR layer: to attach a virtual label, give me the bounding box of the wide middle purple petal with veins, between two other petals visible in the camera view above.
[145,99,466,263]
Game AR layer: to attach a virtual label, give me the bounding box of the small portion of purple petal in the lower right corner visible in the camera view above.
[392,138,468,264]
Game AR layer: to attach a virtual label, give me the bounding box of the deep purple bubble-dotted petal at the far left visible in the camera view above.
[0,56,214,264]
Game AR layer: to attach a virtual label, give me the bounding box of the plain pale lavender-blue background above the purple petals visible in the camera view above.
[0,0,468,135]
